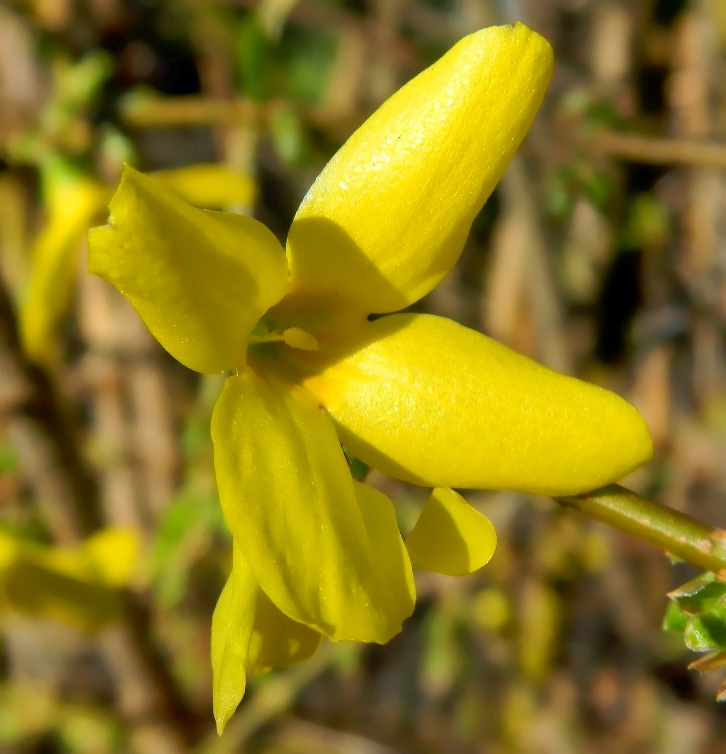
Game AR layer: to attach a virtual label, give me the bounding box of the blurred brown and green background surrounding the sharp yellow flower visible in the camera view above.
[0,0,726,754]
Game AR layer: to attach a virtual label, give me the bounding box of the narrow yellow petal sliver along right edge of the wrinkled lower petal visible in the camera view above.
[353,480,416,612]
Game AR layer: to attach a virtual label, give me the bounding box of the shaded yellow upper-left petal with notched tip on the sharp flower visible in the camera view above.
[89,167,287,373]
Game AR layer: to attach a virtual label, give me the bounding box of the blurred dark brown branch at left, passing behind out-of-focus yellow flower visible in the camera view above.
[0,274,197,754]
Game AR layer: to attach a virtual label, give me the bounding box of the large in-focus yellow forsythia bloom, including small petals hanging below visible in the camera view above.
[90,24,652,729]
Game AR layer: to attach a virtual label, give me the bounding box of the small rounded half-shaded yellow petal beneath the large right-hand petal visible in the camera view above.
[406,487,497,576]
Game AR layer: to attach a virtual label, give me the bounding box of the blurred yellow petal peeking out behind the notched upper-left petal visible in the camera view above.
[151,165,255,209]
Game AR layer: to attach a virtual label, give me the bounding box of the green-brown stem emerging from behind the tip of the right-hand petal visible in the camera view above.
[555,484,726,572]
